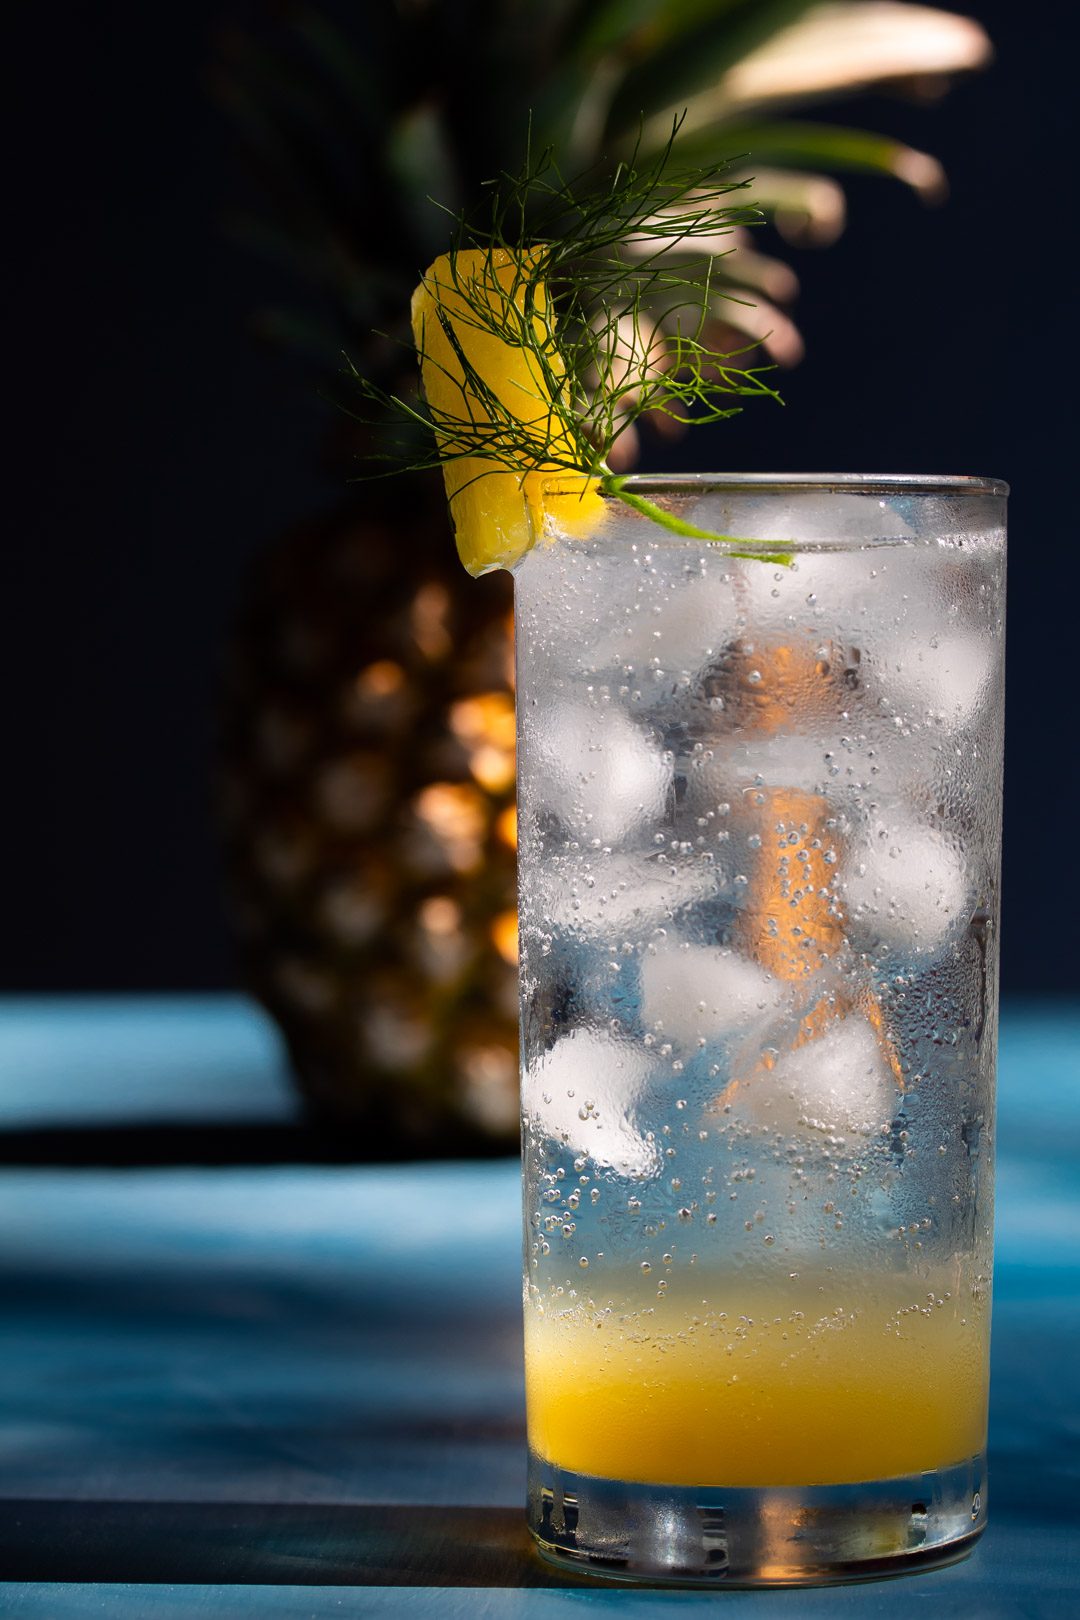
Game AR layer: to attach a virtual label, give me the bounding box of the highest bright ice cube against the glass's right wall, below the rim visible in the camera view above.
[866,630,997,726]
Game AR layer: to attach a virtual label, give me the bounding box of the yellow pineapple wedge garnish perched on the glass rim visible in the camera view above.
[413,248,604,573]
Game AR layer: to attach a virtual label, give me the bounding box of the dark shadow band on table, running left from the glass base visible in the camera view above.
[0,1502,593,1586]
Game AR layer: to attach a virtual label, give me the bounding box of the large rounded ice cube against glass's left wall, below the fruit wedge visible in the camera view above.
[523,703,674,847]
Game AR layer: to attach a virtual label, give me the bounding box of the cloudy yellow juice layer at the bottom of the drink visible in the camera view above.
[525,1272,989,1486]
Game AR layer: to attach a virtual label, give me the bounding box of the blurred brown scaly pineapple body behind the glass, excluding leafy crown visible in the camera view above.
[217,475,520,1160]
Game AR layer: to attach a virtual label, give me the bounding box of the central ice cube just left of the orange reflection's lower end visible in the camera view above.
[641,941,785,1048]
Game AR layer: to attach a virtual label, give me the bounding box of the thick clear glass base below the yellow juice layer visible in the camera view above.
[528,1452,986,1586]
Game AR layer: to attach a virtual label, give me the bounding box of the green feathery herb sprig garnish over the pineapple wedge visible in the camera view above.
[350,125,790,564]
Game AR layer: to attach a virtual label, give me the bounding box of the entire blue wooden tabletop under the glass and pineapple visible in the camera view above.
[0,998,1080,1620]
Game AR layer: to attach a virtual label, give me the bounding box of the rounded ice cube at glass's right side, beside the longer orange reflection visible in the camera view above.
[837,821,970,954]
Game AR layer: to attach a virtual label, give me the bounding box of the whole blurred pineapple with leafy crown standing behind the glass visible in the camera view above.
[217,0,988,1157]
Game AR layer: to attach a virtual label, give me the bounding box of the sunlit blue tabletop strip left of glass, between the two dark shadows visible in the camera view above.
[0,1165,523,1505]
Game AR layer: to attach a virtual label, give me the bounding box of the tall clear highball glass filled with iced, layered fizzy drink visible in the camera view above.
[517,475,1007,1584]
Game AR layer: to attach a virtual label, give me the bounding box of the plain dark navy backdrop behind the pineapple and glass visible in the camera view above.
[0,0,1080,990]
